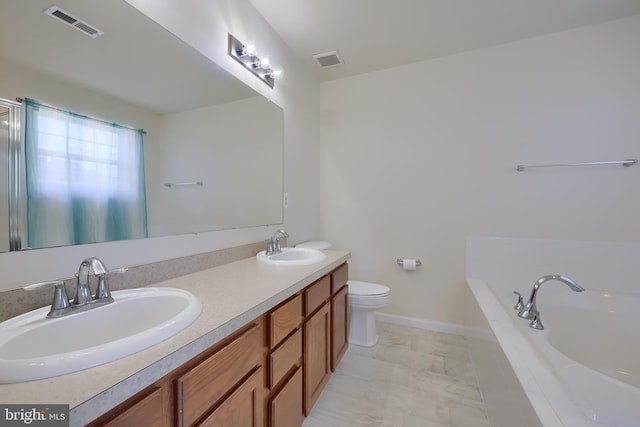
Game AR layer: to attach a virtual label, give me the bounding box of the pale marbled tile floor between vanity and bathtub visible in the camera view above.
[303,322,489,427]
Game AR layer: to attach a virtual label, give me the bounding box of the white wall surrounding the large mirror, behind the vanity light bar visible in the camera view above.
[0,0,319,290]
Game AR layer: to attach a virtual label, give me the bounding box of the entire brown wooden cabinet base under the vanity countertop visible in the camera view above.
[90,264,348,427]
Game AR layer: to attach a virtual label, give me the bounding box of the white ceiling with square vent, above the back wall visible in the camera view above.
[250,0,640,81]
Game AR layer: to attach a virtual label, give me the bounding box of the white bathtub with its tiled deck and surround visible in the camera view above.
[465,238,640,427]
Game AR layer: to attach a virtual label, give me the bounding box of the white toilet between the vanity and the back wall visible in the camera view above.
[296,240,391,347]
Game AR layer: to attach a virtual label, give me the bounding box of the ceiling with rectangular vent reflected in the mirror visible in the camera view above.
[0,0,257,114]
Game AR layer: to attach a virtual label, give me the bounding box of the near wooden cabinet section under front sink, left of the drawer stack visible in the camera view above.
[89,319,264,427]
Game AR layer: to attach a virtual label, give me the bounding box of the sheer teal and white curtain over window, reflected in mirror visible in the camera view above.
[25,99,147,248]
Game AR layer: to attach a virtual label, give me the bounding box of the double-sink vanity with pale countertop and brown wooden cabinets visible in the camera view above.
[0,248,349,427]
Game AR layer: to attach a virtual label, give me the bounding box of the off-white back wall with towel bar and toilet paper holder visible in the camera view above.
[320,17,640,324]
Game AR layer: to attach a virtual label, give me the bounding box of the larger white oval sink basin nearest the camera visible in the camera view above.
[0,288,202,384]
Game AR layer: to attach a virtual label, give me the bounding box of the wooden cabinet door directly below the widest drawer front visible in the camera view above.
[198,367,264,427]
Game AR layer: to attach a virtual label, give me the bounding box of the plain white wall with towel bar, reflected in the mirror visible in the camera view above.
[148,96,284,232]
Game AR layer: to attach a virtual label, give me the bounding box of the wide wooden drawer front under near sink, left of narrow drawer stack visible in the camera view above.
[176,325,262,426]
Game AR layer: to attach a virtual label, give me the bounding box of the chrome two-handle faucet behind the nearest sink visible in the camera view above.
[24,257,127,318]
